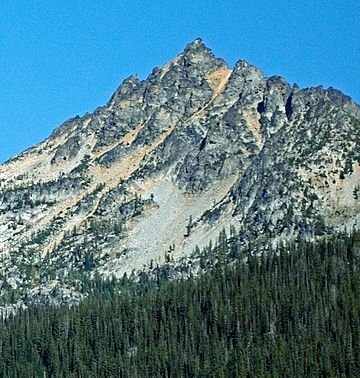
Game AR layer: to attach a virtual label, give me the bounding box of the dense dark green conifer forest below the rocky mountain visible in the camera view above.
[0,234,360,378]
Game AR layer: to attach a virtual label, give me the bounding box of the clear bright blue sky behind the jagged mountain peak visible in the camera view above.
[0,0,360,161]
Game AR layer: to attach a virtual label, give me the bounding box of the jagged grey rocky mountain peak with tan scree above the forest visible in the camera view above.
[0,39,360,306]
